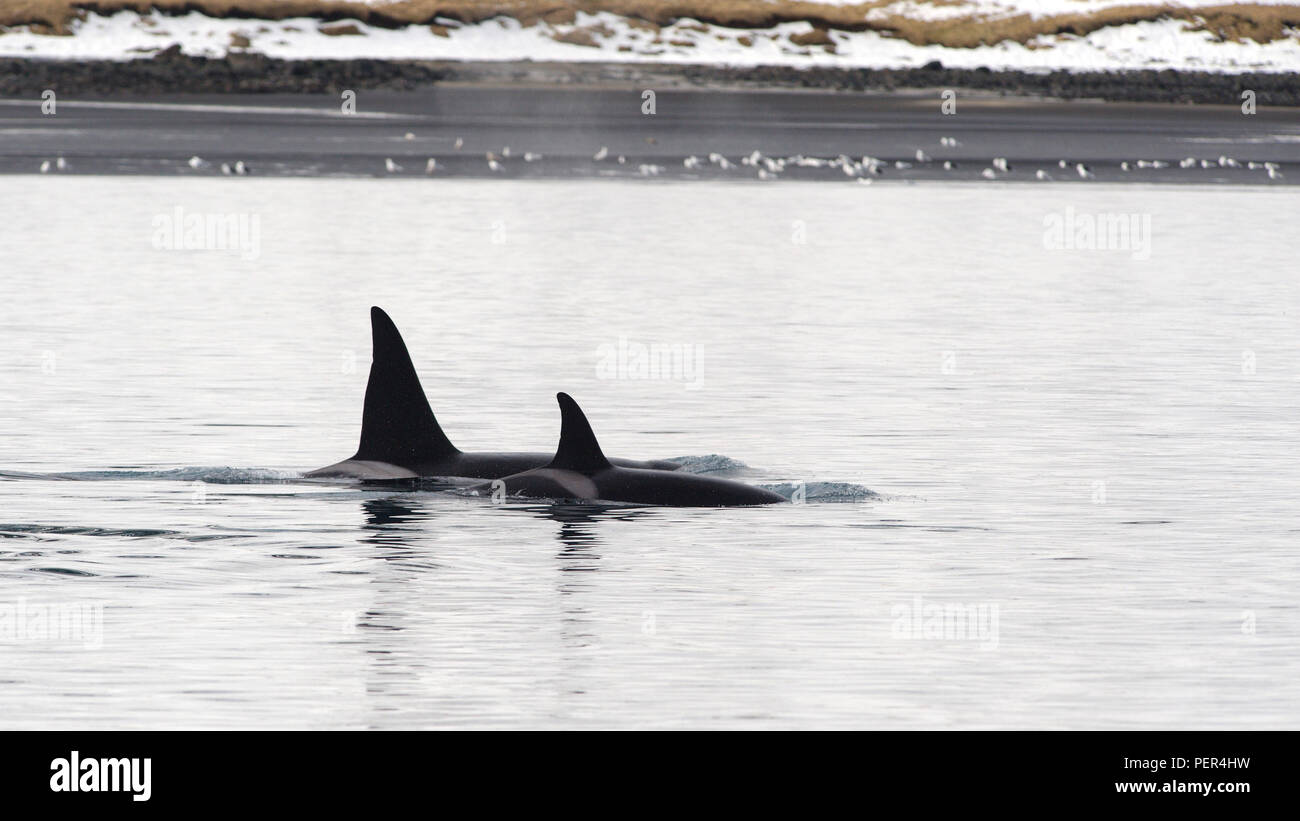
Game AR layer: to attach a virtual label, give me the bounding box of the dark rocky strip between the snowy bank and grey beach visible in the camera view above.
[0,48,1300,107]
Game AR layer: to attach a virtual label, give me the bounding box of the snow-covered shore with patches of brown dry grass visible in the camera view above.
[0,0,1300,74]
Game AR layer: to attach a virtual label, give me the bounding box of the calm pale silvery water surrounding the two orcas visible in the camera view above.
[0,177,1300,729]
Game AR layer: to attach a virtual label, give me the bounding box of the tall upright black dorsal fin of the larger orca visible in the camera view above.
[352,308,459,468]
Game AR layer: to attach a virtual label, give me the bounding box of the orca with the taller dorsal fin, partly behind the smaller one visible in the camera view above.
[306,308,680,481]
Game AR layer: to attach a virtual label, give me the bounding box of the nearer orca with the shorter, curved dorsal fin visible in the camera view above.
[472,394,789,507]
